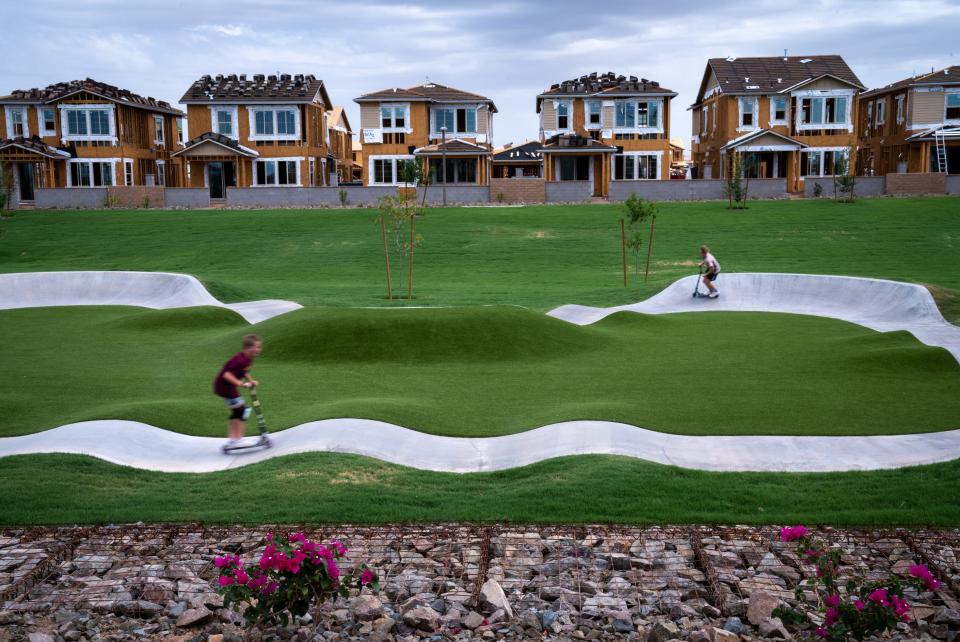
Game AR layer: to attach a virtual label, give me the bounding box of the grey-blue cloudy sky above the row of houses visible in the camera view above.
[0,0,960,150]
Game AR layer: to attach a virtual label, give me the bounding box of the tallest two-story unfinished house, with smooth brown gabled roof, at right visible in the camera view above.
[690,55,866,191]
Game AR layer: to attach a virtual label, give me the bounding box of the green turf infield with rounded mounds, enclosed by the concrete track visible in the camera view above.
[0,306,960,436]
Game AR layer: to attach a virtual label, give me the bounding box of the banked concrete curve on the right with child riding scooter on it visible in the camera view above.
[547,272,960,361]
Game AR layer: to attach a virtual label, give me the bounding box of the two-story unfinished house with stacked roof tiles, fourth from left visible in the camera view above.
[537,72,677,197]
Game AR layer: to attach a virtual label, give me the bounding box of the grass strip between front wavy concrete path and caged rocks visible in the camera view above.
[0,454,960,526]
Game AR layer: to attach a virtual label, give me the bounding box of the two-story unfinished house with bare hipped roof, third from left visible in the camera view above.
[354,82,497,185]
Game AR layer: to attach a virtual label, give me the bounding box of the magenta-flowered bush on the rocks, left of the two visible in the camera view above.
[214,533,380,626]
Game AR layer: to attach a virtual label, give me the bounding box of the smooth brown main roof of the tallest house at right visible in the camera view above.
[697,54,866,101]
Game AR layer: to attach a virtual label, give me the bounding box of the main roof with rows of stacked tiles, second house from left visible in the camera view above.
[180,74,333,109]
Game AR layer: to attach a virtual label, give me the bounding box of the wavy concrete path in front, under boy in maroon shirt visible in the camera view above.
[0,419,960,473]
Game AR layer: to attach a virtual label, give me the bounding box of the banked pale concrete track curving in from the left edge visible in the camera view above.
[0,272,303,323]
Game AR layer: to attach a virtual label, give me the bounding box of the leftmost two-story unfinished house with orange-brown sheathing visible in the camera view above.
[0,78,183,205]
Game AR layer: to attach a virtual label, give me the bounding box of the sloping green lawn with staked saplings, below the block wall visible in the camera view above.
[0,198,960,320]
